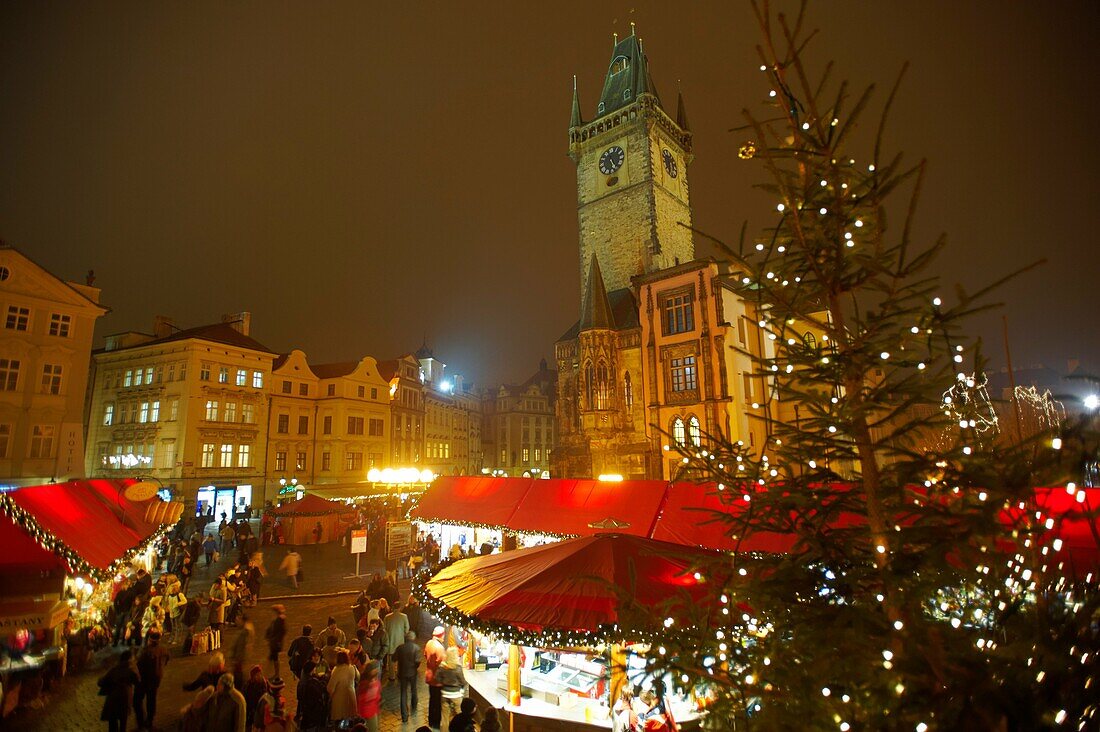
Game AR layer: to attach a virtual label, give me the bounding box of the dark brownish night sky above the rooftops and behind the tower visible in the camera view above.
[0,0,1100,383]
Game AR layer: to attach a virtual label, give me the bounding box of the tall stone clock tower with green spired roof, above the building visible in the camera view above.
[569,25,695,292]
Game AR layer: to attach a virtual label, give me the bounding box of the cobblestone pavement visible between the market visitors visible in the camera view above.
[8,530,447,732]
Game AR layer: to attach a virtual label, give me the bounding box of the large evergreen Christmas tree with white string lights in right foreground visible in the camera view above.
[638,4,1100,731]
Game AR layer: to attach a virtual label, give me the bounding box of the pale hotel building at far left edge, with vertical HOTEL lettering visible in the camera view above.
[0,243,107,485]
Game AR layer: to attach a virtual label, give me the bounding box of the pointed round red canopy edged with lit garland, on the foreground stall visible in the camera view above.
[424,534,721,632]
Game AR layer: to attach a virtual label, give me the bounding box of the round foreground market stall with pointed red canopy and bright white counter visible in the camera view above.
[414,534,726,732]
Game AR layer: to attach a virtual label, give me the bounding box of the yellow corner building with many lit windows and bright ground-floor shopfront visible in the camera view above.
[86,313,276,518]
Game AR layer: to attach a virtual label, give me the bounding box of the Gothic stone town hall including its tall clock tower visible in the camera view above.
[550,32,796,480]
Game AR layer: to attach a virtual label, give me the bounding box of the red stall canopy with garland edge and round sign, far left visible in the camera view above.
[0,480,183,580]
